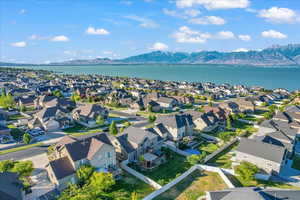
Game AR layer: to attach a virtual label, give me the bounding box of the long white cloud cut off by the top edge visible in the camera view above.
[175,0,250,10]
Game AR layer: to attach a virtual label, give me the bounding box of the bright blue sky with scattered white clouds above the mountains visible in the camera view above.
[0,0,300,63]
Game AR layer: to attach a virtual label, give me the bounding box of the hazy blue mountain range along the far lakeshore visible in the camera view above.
[0,44,300,66]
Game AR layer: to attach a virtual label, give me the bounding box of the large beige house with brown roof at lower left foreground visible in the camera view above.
[46,133,120,190]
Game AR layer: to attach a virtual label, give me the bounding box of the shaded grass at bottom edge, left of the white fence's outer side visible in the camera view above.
[111,173,154,200]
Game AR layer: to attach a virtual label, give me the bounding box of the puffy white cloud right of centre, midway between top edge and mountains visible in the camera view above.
[172,26,212,43]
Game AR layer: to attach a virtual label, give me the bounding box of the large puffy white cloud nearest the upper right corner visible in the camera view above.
[258,7,300,23]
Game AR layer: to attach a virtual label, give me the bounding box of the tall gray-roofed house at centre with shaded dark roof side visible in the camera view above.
[155,114,195,141]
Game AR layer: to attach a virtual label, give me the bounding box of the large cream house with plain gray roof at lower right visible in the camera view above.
[235,138,286,174]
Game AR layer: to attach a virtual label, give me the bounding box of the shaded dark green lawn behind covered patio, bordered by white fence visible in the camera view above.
[131,152,191,185]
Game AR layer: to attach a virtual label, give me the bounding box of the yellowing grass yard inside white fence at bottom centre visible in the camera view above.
[154,170,227,200]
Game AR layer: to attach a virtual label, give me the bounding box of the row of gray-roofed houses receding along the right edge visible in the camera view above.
[235,106,300,175]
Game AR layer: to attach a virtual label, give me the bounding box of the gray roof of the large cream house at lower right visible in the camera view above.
[236,138,285,163]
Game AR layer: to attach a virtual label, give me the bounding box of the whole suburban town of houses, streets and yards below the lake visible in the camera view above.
[0,67,300,200]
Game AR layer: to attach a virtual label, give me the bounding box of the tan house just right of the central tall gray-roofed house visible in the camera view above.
[186,110,219,132]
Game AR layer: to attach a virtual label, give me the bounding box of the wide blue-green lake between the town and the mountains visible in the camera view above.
[6,64,300,90]
